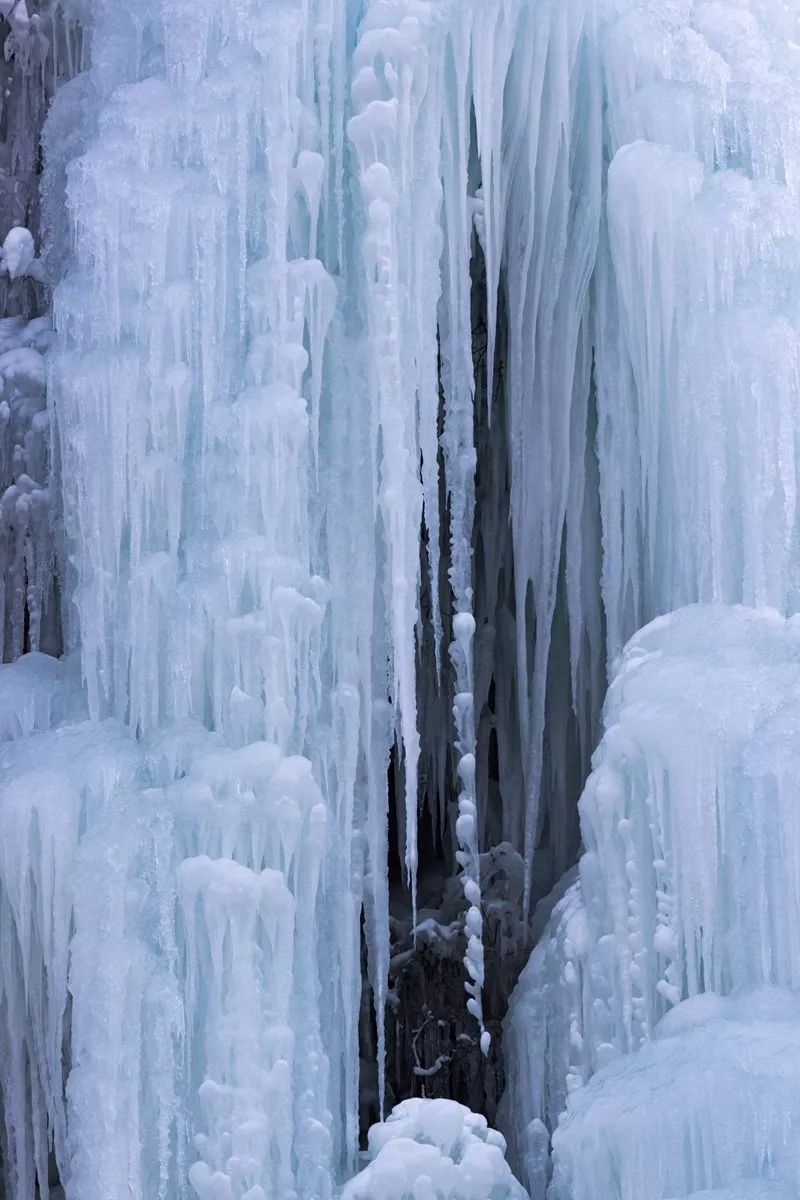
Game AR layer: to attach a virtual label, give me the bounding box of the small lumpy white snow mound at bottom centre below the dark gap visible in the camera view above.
[342,1099,527,1200]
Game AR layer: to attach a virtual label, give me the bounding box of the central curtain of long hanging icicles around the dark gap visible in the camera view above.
[349,4,602,1080]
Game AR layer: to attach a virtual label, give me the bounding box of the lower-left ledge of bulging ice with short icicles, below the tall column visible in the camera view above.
[0,705,330,1200]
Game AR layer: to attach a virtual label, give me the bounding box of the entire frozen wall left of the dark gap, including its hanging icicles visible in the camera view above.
[2,0,591,1200]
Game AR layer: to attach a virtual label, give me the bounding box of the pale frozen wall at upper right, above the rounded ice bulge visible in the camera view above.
[594,2,800,661]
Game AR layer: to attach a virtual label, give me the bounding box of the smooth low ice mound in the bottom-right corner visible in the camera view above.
[549,989,800,1200]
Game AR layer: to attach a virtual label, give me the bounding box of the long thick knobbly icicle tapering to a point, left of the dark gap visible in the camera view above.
[348,2,440,923]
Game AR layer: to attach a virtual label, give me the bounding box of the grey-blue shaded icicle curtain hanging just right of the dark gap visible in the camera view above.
[476,4,601,911]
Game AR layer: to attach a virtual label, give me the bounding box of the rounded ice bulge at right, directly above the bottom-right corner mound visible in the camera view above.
[581,606,800,1049]
